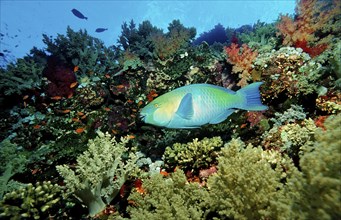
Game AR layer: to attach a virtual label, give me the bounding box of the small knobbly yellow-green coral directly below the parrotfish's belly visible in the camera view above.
[163,137,223,169]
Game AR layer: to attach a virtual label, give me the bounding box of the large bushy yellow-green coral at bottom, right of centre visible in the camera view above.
[207,139,302,219]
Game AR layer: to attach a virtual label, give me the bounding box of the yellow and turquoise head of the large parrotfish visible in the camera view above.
[140,96,174,127]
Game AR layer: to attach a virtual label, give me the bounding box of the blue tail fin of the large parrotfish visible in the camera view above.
[236,82,268,111]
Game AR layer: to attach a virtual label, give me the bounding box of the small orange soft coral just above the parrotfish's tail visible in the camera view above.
[225,43,258,87]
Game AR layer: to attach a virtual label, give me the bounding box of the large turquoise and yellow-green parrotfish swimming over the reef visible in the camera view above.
[140,82,268,128]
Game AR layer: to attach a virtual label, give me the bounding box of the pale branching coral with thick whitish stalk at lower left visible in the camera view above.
[57,132,138,216]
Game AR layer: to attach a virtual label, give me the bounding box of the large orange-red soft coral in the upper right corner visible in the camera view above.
[277,0,340,56]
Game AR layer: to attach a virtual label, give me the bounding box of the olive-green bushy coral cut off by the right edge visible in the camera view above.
[300,114,341,219]
